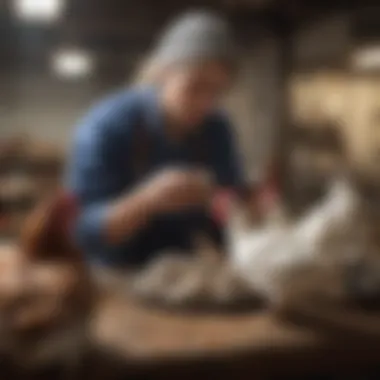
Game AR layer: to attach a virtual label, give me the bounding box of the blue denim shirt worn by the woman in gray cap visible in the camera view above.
[66,87,241,265]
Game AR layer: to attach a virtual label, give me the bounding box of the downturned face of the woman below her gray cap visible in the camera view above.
[163,62,231,129]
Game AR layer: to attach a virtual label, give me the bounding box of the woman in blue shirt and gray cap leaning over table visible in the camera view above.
[68,12,240,265]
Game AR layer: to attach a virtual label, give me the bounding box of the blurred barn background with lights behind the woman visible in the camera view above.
[0,0,380,236]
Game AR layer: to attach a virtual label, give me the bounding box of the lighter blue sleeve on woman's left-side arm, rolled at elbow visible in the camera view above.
[67,100,134,252]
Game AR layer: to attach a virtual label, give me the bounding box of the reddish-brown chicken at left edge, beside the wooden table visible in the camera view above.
[0,194,94,376]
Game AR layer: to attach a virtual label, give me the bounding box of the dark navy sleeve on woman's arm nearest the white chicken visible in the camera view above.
[211,115,244,188]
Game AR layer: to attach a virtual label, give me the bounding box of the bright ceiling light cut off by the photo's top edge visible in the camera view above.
[13,0,64,23]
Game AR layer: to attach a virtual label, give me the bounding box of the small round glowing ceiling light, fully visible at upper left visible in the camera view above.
[52,50,94,79]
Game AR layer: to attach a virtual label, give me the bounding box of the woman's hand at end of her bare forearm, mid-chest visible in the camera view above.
[142,169,214,212]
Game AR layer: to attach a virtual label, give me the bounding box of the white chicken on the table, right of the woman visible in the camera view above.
[228,180,368,306]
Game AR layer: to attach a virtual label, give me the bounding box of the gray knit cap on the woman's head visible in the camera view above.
[153,11,236,68]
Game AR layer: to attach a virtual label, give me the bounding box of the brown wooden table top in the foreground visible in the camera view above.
[93,290,380,379]
